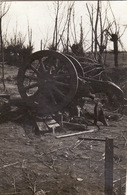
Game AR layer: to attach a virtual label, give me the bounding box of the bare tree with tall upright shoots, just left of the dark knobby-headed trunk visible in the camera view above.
[86,0,112,64]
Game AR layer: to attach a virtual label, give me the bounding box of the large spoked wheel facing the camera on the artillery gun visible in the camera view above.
[18,50,78,114]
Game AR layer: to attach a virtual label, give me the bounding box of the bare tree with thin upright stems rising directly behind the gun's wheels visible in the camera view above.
[49,1,75,50]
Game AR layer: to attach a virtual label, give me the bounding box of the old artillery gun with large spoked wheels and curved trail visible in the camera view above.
[18,50,126,114]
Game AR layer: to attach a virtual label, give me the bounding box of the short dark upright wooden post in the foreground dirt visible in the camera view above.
[105,138,113,195]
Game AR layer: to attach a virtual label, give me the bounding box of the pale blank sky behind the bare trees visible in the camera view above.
[2,1,127,51]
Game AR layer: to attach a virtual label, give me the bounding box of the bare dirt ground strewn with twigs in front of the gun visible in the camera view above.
[0,63,127,195]
